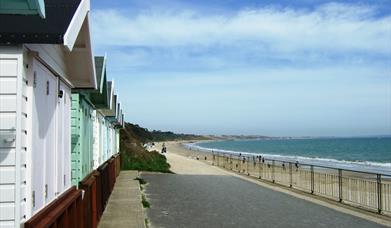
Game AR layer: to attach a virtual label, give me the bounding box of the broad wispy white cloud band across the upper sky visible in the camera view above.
[93,3,391,56]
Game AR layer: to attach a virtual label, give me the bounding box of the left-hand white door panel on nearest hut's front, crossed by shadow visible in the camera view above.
[30,60,57,212]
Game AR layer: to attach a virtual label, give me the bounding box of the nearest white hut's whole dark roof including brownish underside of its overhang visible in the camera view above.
[0,0,97,89]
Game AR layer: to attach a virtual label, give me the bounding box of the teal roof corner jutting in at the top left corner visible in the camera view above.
[0,0,45,18]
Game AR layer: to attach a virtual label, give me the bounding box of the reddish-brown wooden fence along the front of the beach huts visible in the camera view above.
[25,155,121,228]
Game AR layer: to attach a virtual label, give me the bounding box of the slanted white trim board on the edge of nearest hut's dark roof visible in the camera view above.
[64,0,90,51]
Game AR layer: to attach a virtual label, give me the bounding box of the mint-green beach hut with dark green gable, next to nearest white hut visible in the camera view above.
[72,56,111,183]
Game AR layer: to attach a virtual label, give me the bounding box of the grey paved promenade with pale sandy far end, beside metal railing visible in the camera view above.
[142,153,383,228]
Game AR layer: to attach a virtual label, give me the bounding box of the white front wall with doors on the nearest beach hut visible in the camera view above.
[26,56,71,220]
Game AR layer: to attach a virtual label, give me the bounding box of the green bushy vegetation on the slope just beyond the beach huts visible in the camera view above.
[120,123,205,173]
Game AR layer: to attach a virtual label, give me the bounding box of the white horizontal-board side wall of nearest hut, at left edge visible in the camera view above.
[0,46,29,228]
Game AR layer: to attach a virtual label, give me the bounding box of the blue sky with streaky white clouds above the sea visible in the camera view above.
[90,0,391,136]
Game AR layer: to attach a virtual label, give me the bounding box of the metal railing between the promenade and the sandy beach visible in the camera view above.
[211,152,391,215]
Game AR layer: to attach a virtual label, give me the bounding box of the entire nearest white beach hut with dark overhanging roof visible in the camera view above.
[0,0,97,227]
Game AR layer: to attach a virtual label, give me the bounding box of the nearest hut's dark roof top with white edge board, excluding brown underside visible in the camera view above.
[0,0,84,46]
